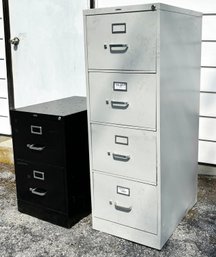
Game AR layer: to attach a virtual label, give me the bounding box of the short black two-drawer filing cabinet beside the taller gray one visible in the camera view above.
[11,97,91,227]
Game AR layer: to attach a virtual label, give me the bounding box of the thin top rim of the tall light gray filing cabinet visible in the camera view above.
[83,3,202,16]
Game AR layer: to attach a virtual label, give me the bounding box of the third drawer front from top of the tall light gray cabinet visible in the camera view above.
[91,124,156,184]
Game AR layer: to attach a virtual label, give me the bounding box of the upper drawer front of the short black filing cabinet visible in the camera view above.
[11,112,65,165]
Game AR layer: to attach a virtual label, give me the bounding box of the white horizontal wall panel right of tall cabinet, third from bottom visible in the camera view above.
[200,93,216,117]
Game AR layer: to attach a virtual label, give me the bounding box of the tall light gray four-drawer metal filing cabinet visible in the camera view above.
[84,4,202,249]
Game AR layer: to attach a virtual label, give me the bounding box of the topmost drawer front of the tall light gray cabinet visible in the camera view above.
[87,12,157,71]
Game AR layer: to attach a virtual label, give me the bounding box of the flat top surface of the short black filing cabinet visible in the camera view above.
[12,96,86,116]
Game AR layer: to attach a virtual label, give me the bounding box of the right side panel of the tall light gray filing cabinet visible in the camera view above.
[159,11,202,244]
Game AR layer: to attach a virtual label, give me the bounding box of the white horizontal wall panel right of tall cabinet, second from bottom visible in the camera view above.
[199,118,216,141]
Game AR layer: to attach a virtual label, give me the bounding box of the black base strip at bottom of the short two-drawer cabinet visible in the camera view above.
[17,200,90,228]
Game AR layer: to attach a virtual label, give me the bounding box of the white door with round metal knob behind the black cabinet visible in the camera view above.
[8,0,89,108]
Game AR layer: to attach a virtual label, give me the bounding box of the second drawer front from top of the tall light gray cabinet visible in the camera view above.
[89,72,156,129]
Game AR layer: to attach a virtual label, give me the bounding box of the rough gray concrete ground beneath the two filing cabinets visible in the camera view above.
[0,164,216,257]
